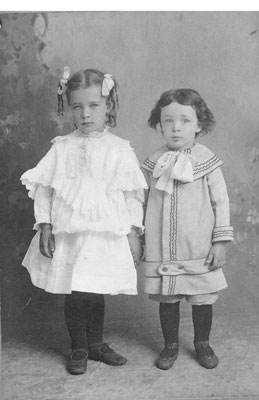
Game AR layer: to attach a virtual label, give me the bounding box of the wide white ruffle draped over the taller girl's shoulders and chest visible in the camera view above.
[21,130,147,221]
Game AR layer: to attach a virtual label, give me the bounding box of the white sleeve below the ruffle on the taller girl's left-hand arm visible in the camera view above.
[33,185,53,230]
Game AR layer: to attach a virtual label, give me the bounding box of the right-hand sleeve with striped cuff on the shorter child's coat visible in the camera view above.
[207,167,236,243]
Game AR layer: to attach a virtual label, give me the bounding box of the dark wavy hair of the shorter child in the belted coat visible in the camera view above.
[148,89,216,136]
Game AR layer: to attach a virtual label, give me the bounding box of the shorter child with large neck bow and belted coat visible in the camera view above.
[143,89,233,369]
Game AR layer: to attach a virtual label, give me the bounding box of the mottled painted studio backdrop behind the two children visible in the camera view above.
[0,12,259,320]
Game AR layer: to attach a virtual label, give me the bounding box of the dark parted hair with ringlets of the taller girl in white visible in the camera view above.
[66,69,119,127]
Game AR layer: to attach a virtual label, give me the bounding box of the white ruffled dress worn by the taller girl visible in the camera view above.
[21,129,147,295]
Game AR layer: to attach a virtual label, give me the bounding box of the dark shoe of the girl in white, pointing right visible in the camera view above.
[89,343,127,366]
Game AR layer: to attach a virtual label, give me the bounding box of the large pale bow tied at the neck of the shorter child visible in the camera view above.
[153,151,195,194]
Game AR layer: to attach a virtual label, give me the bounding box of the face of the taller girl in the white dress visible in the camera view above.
[69,86,108,135]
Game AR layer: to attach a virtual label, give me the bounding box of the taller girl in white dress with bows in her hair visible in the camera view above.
[21,69,146,374]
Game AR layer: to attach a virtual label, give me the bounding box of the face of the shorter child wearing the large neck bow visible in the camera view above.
[160,102,201,149]
